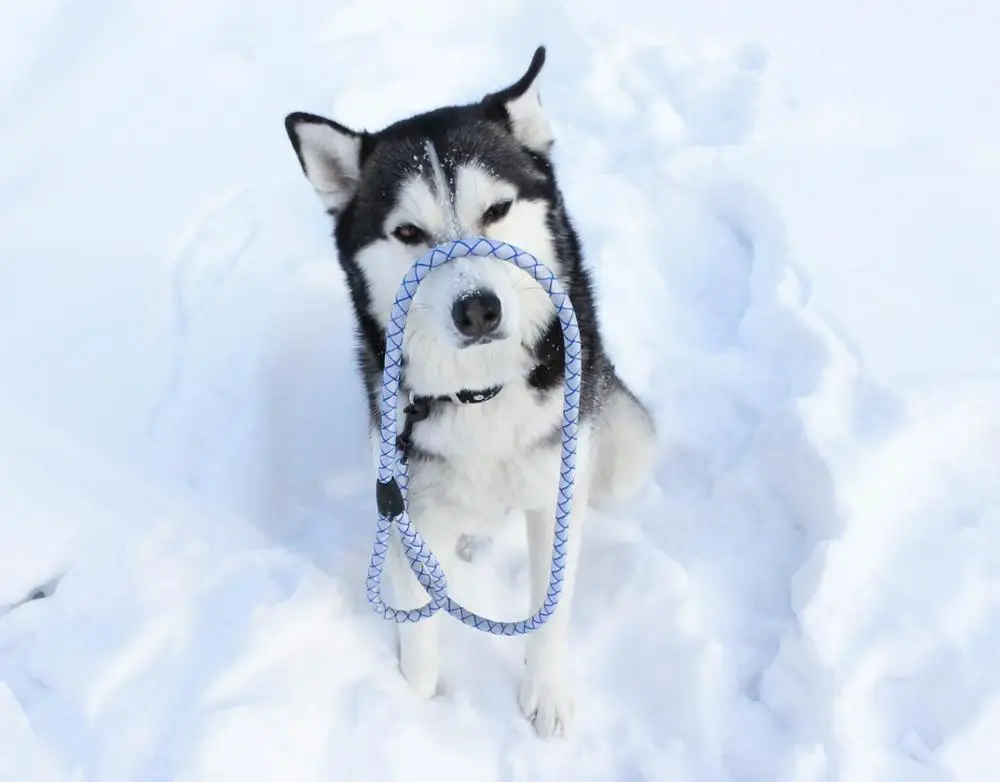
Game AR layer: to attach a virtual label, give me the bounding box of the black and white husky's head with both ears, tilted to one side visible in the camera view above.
[285,48,559,392]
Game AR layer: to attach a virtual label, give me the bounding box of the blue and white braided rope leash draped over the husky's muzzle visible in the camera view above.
[366,238,582,635]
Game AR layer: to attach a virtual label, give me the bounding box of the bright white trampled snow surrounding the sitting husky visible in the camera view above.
[0,0,1000,782]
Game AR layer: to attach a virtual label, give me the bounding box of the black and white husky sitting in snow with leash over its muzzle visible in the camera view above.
[285,47,655,737]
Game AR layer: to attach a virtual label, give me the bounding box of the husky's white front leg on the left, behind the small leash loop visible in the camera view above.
[389,508,457,698]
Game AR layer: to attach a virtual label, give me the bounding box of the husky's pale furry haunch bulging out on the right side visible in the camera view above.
[590,373,656,508]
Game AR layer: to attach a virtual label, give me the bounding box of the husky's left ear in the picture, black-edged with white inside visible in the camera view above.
[285,111,364,214]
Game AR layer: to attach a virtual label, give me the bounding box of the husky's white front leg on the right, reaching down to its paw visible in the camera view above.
[518,450,587,738]
